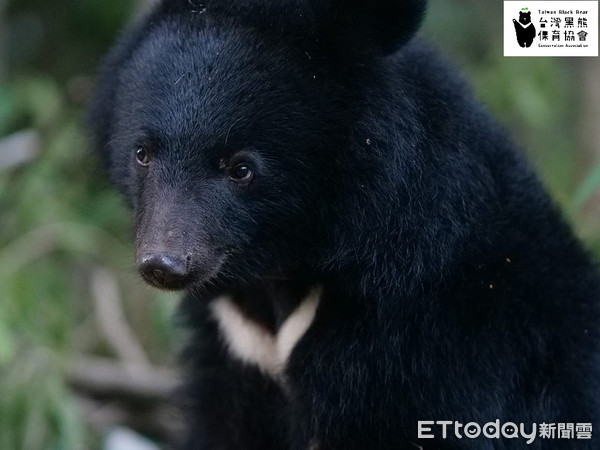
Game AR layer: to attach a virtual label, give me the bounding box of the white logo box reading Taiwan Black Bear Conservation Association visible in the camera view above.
[504,0,598,56]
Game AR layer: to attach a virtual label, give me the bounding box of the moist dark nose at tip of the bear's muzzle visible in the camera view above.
[137,252,189,288]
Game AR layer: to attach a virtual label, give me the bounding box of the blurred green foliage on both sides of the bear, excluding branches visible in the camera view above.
[0,0,600,449]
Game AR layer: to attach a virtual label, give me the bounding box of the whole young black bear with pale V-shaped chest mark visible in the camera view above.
[88,0,600,450]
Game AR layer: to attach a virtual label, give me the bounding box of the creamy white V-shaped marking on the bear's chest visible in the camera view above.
[210,288,321,378]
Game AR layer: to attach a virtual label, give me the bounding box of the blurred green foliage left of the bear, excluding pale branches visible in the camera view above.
[0,0,174,449]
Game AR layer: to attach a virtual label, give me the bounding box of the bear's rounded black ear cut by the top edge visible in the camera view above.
[330,0,427,54]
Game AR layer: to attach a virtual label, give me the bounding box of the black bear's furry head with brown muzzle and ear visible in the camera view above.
[88,0,424,289]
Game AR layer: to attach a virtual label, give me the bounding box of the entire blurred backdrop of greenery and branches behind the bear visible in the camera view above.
[0,0,600,450]
